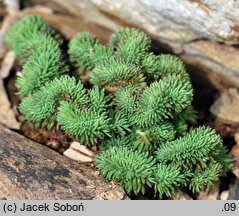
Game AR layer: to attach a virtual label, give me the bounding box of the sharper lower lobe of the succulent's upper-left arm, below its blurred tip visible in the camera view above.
[16,33,68,96]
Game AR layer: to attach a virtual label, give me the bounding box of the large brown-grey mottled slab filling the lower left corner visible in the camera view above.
[0,126,127,200]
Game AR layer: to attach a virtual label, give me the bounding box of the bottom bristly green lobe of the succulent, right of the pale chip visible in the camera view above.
[97,146,156,194]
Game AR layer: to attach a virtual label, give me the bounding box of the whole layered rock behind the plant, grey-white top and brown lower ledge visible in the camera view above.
[25,0,239,90]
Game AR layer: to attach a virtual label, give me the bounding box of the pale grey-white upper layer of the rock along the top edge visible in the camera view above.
[26,0,239,44]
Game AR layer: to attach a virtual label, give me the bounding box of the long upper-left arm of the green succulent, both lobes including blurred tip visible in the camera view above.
[5,16,68,96]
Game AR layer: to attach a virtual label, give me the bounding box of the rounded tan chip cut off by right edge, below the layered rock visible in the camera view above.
[210,88,239,124]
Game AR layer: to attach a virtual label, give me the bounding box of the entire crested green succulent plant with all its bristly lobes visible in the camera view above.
[6,16,231,197]
